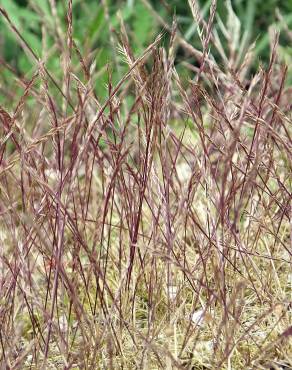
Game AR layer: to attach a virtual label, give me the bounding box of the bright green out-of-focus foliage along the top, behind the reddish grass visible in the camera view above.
[0,0,292,73]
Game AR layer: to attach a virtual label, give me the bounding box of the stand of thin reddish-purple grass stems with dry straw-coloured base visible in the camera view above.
[0,1,292,370]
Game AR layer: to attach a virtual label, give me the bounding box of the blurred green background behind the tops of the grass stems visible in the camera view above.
[0,0,292,101]
